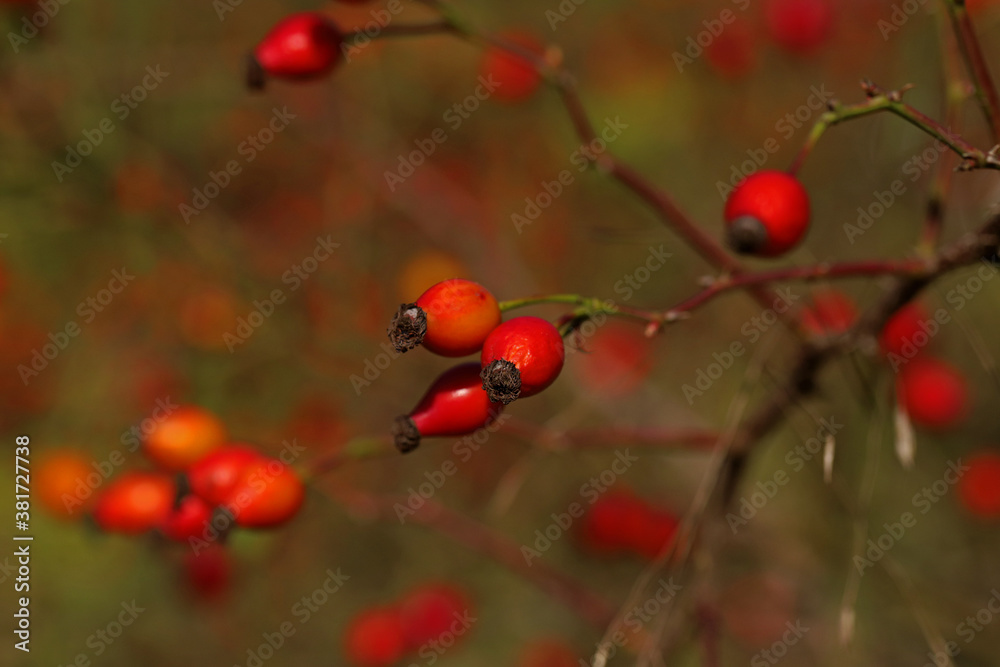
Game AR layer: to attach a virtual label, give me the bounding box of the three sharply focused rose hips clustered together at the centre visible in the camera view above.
[389,278,565,453]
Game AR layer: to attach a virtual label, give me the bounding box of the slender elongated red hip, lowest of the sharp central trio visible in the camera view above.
[392,361,503,454]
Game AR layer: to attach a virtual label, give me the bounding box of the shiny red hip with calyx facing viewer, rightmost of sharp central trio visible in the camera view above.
[480,315,566,405]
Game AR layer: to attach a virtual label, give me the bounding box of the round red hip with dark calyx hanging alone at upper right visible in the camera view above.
[725,169,810,257]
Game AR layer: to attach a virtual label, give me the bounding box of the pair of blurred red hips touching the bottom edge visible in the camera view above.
[344,582,472,667]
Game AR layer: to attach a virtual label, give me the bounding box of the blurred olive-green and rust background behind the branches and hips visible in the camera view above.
[0,0,1000,667]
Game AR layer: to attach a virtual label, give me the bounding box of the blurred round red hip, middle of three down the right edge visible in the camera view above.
[898,359,969,430]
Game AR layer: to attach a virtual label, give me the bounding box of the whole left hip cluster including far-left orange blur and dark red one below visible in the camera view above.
[38,405,305,593]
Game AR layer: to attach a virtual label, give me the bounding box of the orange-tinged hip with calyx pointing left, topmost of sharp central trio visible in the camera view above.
[389,278,500,357]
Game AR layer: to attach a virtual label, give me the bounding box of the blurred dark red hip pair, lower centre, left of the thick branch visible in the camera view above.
[577,490,680,559]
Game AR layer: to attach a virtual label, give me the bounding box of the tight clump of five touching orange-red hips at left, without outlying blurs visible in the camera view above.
[92,406,305,542]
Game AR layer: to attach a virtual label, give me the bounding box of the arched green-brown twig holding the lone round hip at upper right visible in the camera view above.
[788,81,1000,174]
